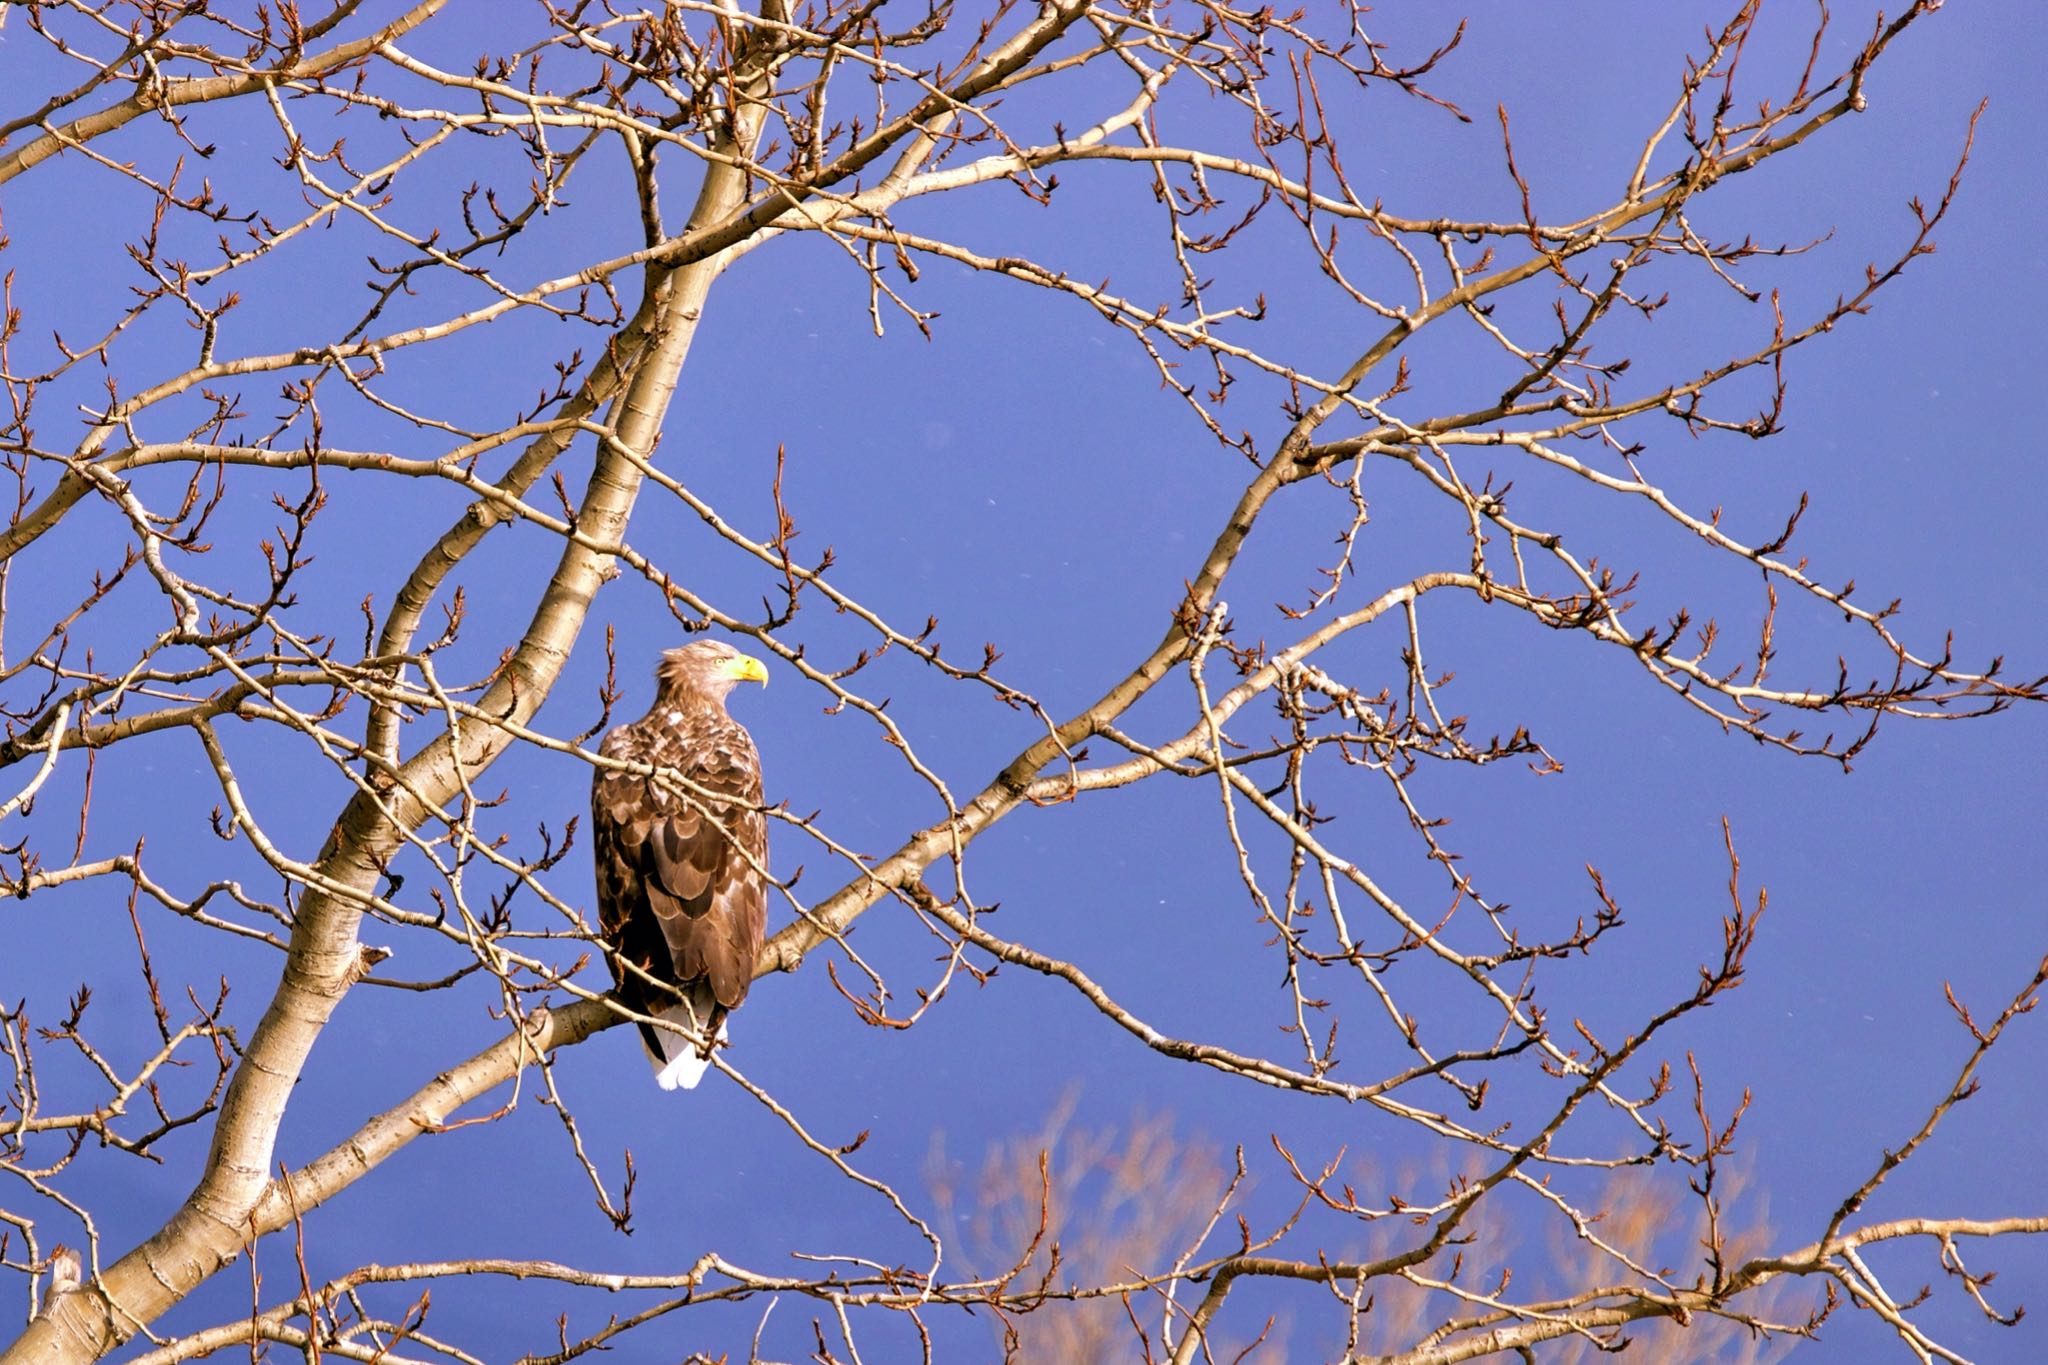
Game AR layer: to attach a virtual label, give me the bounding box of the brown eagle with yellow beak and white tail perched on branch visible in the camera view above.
[590,641,768,1091]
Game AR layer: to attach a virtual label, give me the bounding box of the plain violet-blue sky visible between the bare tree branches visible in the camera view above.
[0,2,2048,1361]
